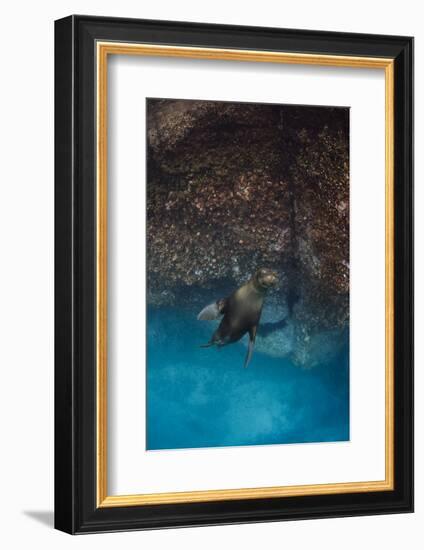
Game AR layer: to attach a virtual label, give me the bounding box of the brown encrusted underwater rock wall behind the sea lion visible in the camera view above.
[147,99,349,366]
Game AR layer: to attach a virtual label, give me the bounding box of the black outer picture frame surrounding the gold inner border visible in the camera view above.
[55,15,413,534]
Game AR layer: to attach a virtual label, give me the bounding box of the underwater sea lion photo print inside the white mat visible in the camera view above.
[146,98,349,450]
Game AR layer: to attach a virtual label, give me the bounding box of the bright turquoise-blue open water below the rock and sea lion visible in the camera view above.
[146,308,349,450]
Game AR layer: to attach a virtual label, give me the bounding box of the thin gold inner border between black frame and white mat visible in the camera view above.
[96,41,394,508]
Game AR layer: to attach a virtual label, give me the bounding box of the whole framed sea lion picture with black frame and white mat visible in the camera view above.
[55,16,413,534]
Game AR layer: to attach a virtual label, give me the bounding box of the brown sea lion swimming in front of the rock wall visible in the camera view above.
[197,268,277,367]
